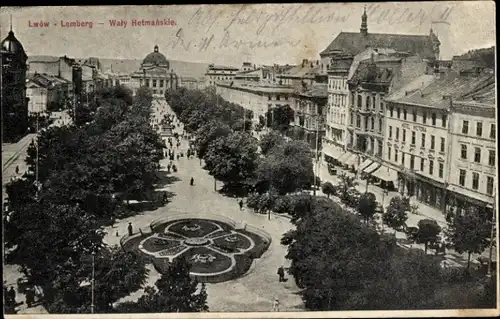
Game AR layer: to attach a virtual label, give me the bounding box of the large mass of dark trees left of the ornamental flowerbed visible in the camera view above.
[4,87,206,313]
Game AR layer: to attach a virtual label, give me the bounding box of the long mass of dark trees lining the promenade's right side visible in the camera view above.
[166,89,496,310]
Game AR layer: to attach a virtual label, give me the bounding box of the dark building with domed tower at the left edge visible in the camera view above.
[0,28,28,142]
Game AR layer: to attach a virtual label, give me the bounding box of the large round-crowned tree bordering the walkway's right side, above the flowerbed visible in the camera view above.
[205,132,257,188]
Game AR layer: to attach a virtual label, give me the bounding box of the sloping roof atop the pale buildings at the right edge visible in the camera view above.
[386,72,495,108]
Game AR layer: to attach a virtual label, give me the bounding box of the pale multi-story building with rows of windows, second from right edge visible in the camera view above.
[382,69,491,210]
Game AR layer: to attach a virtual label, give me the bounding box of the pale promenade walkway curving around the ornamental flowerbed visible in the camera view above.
[103,102,303,312]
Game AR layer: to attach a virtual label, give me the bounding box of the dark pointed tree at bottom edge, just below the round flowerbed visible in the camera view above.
[117,258,208,313]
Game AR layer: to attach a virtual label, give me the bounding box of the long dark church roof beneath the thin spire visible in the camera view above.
[320,32,434,58]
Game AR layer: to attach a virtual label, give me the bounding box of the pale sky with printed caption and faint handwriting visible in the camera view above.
[0,1,496,66]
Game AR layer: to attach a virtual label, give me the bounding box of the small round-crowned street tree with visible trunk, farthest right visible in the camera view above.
[446,208,492,269]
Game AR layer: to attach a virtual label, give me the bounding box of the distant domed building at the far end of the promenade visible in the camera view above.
[131,45,179,97]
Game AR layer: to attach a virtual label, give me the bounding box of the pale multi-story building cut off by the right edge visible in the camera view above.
[446,74,498,218]
